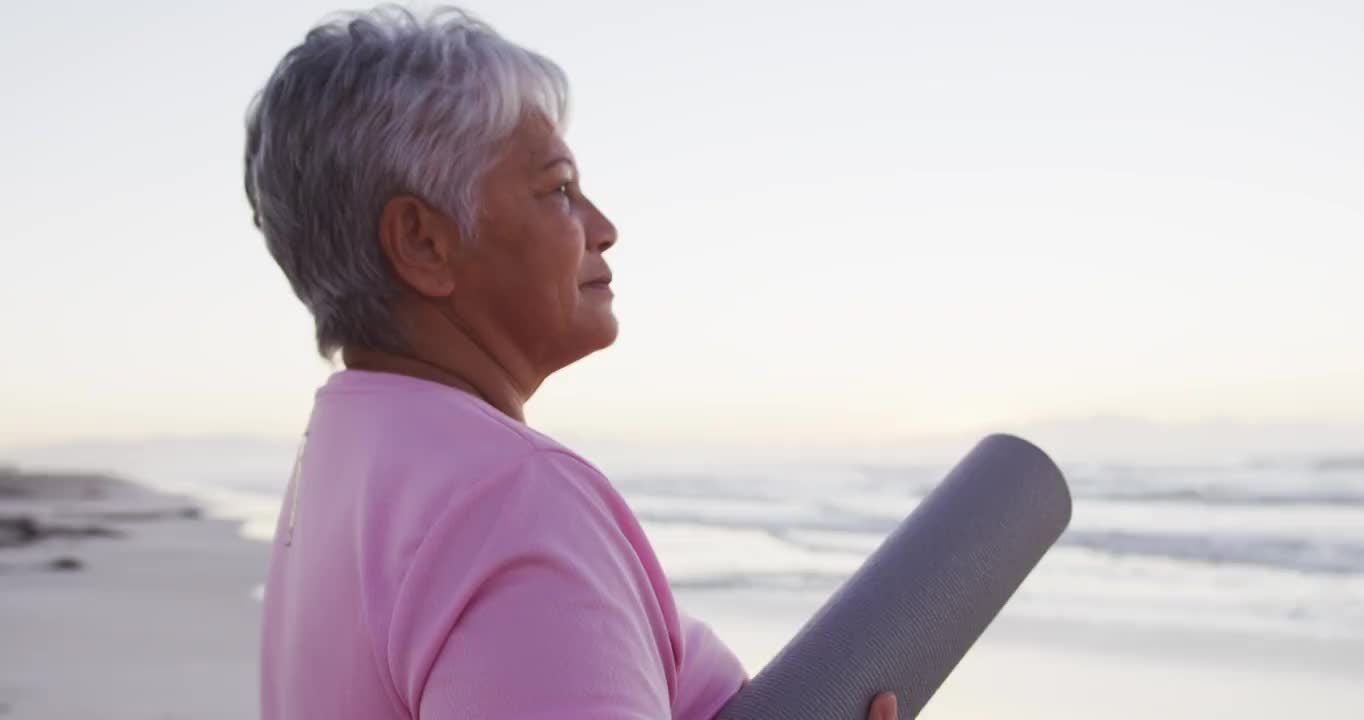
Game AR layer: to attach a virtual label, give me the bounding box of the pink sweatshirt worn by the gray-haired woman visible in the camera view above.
[261,371,745,720]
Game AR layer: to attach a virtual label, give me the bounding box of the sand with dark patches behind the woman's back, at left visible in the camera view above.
[0,475,267,720]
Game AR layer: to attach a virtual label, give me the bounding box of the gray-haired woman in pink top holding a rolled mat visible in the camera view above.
[246,8,895,720]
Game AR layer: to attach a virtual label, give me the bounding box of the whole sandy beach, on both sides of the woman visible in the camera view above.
[0,466,1364,720]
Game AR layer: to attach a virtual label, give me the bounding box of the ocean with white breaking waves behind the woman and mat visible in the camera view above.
[5,439,1364,649]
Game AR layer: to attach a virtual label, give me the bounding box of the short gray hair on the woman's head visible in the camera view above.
[246,5,569,357]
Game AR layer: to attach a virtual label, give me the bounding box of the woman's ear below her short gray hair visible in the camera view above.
[379,195,460,297]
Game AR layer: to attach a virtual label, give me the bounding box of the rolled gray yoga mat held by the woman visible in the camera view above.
[717,435,1071,720]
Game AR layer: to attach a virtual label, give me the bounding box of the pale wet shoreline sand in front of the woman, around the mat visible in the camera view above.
[678,590,1364,720]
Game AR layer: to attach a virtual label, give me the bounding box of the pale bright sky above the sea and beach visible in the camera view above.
[0,0,1364,447]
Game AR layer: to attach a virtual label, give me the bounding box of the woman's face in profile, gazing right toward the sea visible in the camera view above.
[453,116,617,374]
